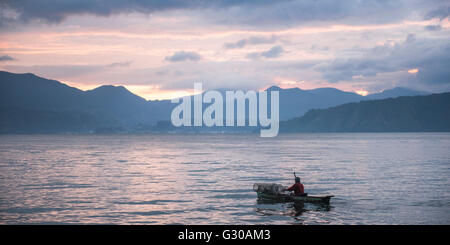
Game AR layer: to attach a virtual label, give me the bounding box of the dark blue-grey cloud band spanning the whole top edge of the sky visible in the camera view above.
[0,0,448,26]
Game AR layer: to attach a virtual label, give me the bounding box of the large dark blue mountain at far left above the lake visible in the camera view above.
[0,71,157,133]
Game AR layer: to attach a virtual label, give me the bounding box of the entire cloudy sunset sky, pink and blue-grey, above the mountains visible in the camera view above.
[0,0,450,100]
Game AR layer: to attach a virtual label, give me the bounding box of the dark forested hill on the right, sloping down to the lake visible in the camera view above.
[280,93,450,132]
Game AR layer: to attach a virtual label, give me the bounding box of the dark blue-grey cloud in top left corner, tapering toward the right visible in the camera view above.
[0,0,287,23]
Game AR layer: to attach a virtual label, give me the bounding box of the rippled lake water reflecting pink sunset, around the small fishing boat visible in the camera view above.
[0,133,450,225]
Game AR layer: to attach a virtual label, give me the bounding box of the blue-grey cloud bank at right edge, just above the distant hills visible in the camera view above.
[316,35,450,84]
